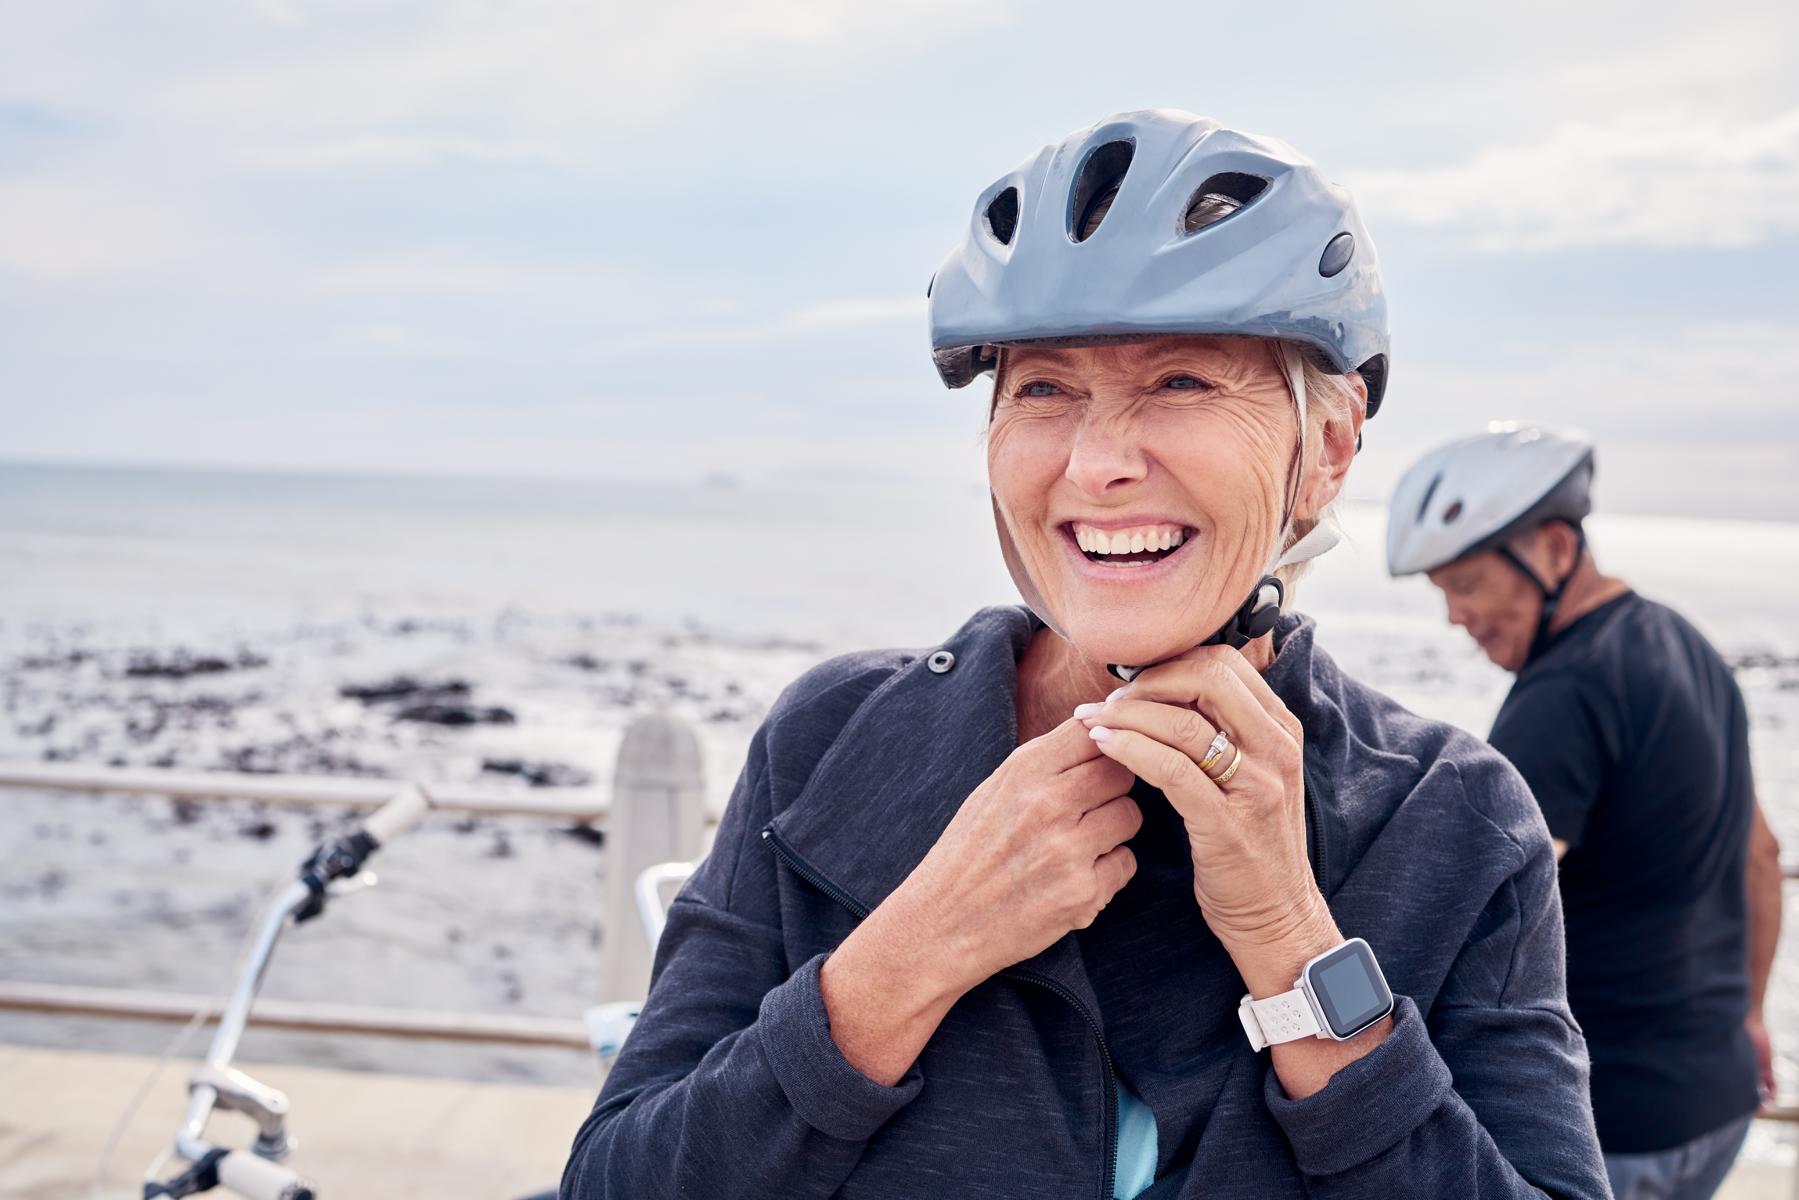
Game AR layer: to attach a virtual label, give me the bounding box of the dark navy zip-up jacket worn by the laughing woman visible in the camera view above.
[561,604,1610,1200]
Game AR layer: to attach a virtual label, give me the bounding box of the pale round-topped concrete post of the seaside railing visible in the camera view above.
[599,712,705,1000]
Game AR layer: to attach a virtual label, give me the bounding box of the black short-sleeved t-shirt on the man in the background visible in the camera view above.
[1491,592,1759,1153]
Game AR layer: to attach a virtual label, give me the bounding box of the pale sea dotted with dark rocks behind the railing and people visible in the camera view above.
[0,464,1799,1151]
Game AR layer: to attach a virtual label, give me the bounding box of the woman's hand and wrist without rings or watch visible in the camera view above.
[819,718,1142,1087]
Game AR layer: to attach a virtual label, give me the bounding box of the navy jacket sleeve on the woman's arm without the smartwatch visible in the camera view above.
[558,723,923,1200]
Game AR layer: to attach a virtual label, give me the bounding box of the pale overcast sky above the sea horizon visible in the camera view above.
[0,0,1799,518]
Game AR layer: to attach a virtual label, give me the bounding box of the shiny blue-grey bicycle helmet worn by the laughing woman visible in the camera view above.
[926,108,1387,417]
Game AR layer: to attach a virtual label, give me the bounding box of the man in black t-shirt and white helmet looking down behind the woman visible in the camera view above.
[1387,423,1781,1200]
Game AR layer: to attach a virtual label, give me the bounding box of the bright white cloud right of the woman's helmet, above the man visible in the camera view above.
[1349,108,1799,252]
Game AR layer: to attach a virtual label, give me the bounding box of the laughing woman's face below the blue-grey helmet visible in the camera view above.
[988,335,1353,662]
